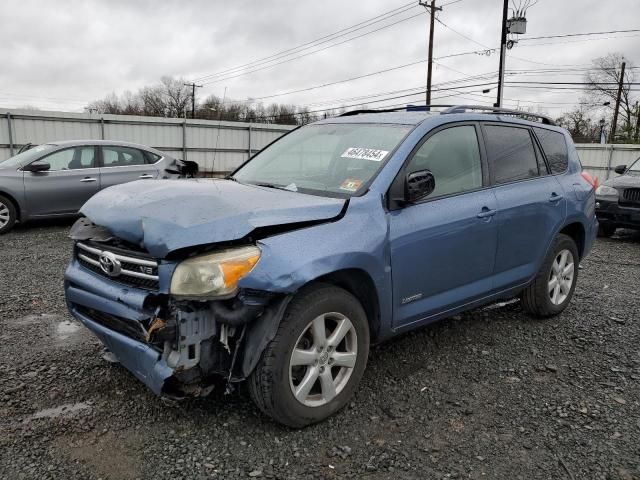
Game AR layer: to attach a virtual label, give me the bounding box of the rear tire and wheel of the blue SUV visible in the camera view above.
[521,234,580,318]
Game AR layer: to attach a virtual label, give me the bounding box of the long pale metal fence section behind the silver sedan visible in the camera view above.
[0,109,294,173]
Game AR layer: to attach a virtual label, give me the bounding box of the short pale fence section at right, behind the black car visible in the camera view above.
[576,143,640,181]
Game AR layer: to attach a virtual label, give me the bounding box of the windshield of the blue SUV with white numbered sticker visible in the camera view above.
[232,123,413,197]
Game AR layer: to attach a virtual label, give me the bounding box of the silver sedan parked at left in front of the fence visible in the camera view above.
[0,140,197,234]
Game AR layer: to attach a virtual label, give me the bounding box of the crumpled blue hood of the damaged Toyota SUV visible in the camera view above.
[80,180,345,258]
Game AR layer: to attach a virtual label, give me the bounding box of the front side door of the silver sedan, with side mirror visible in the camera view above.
[24,146,100,216]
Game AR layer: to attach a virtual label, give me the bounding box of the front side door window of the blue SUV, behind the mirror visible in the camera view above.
[407,125,482,197]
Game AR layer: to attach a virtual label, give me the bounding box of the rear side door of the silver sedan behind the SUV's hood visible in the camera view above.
[100,145,158,188]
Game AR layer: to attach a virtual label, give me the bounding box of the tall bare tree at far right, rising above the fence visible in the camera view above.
[585,53,638,141]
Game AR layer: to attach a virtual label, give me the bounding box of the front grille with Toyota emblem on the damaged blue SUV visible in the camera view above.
[76,242,159,290]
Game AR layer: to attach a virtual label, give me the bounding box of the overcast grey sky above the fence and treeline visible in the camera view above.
[0,0,640,116]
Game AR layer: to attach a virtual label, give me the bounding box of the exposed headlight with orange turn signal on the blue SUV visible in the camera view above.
[171,246,260,298]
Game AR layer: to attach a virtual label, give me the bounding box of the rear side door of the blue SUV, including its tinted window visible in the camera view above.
[482,123,566,290]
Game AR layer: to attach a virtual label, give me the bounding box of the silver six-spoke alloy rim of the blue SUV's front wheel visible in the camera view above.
[289,312,358,407]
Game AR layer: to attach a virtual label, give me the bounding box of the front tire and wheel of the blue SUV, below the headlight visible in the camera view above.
[248,284,369,428]
